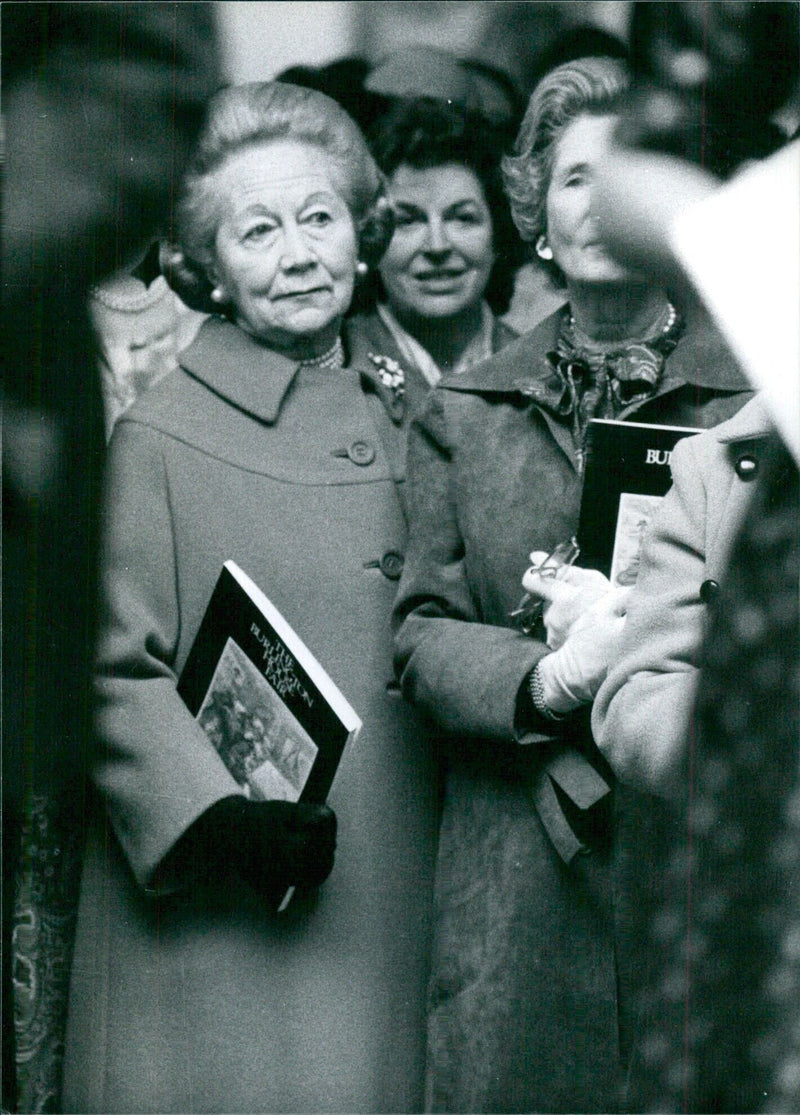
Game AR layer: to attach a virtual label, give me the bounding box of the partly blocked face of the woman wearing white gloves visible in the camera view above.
[546,116,629,284]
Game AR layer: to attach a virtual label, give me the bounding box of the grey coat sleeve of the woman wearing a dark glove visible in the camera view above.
[93,420,240,888]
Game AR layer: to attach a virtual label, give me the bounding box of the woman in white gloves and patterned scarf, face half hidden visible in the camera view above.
[395,58,750,1112]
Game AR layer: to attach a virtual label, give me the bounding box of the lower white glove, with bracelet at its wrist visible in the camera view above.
[537,589,630,712]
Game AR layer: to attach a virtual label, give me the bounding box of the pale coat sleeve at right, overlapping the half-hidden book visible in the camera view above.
[591,396,772,797]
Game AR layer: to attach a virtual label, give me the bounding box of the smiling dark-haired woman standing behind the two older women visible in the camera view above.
[350,97,523,419]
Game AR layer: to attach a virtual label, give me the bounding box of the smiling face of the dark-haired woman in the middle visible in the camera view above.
[379,163,494,318]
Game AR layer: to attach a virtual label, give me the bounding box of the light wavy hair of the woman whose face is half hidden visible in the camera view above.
[502,57,629,254]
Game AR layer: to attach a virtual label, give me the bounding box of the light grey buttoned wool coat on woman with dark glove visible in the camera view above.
[65,319,436,1113]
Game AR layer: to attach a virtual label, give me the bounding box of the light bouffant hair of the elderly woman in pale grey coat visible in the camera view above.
[162,81,394,313]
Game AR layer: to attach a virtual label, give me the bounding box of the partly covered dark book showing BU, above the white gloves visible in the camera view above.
[578,418,701,588]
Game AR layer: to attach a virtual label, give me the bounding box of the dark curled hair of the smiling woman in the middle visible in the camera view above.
[361,97,524,313]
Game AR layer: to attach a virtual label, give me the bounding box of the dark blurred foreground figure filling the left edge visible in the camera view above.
[2,3,216,1111]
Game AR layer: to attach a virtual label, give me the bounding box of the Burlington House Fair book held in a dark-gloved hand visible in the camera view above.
[177,561,362,803]
